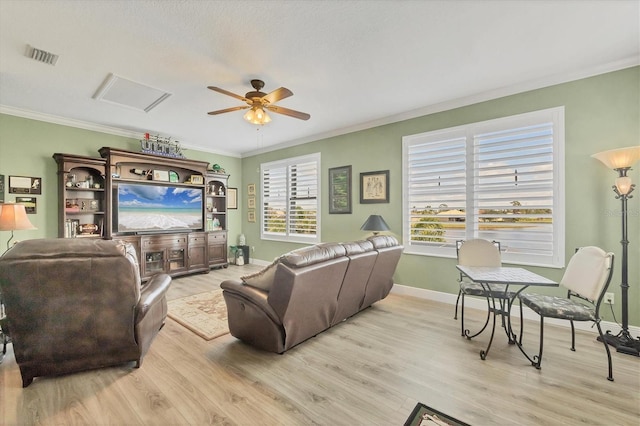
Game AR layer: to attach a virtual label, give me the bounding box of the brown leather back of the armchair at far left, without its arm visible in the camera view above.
[0,239,140,364]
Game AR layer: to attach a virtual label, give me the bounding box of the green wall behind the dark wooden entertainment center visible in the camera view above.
[0,114,242,253]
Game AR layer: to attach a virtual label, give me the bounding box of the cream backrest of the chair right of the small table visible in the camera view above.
[560,246,613,301]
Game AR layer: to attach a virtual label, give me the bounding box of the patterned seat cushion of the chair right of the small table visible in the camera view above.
[519,293,596,321]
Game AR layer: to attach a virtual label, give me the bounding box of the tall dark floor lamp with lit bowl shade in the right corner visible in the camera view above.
[592,146,640,356]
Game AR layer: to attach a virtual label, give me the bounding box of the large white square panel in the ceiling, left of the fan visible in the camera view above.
[93,74,171,112]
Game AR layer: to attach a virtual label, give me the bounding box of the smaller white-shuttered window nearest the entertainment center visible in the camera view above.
[260,154,320,243]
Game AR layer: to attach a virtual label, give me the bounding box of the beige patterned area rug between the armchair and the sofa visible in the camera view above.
[167,289,229,340]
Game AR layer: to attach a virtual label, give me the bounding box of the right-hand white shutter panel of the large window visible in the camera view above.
[473,122,554,258]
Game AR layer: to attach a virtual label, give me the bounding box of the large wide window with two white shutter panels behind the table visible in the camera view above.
[403,107,564,267]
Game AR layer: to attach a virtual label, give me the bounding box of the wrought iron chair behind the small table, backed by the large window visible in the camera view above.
[454,239,516,339]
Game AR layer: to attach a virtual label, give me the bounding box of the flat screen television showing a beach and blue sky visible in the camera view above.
[113,182,204,234]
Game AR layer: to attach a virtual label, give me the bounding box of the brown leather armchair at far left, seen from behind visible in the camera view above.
[0,238,171,387]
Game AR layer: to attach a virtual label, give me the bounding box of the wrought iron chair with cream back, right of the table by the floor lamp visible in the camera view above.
[517,246,614,381]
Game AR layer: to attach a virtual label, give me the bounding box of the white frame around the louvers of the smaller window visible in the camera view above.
[259,152,322,244]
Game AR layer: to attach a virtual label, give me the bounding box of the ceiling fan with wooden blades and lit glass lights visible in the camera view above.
[208,80,311,124]
